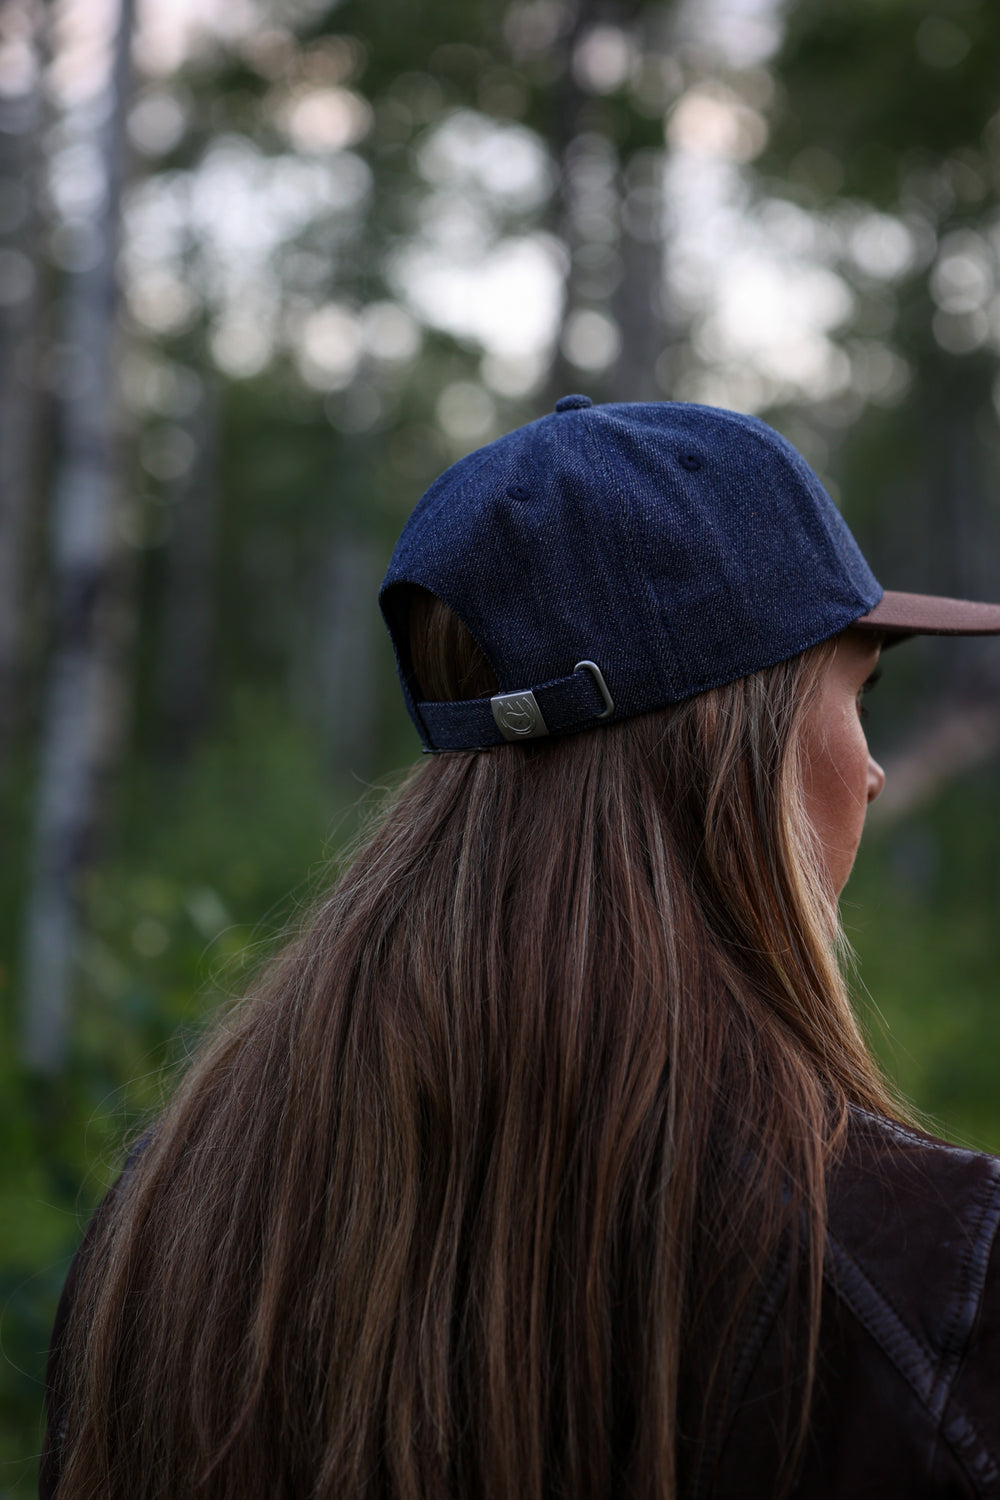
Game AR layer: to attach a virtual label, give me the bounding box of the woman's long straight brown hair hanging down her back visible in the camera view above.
[52,596,892,1500]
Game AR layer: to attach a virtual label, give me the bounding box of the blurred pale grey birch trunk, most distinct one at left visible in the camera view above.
[22,0,135,1076]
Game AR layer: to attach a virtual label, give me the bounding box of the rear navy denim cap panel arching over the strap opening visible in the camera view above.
[382,408,671,696]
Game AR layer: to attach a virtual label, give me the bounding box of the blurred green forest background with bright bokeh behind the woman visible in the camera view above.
[0,0,1000,1496]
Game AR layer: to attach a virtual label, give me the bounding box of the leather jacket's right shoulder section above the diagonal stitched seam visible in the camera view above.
[826,1110,1000,1494]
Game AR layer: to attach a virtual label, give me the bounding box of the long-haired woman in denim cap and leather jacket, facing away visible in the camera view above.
[42,396,1000,1500]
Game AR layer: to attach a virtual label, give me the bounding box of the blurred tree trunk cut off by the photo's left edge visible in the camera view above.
[0,0,45,773]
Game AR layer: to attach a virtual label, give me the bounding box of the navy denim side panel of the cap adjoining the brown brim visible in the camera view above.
[598,404,882,699]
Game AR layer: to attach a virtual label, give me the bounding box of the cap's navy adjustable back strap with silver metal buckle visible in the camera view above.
[417,662,615,750]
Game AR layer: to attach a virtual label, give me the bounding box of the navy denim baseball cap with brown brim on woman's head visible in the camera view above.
[379,396,1000,750]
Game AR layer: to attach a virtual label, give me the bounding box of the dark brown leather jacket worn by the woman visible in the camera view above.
[39,1112,1000,1500]
